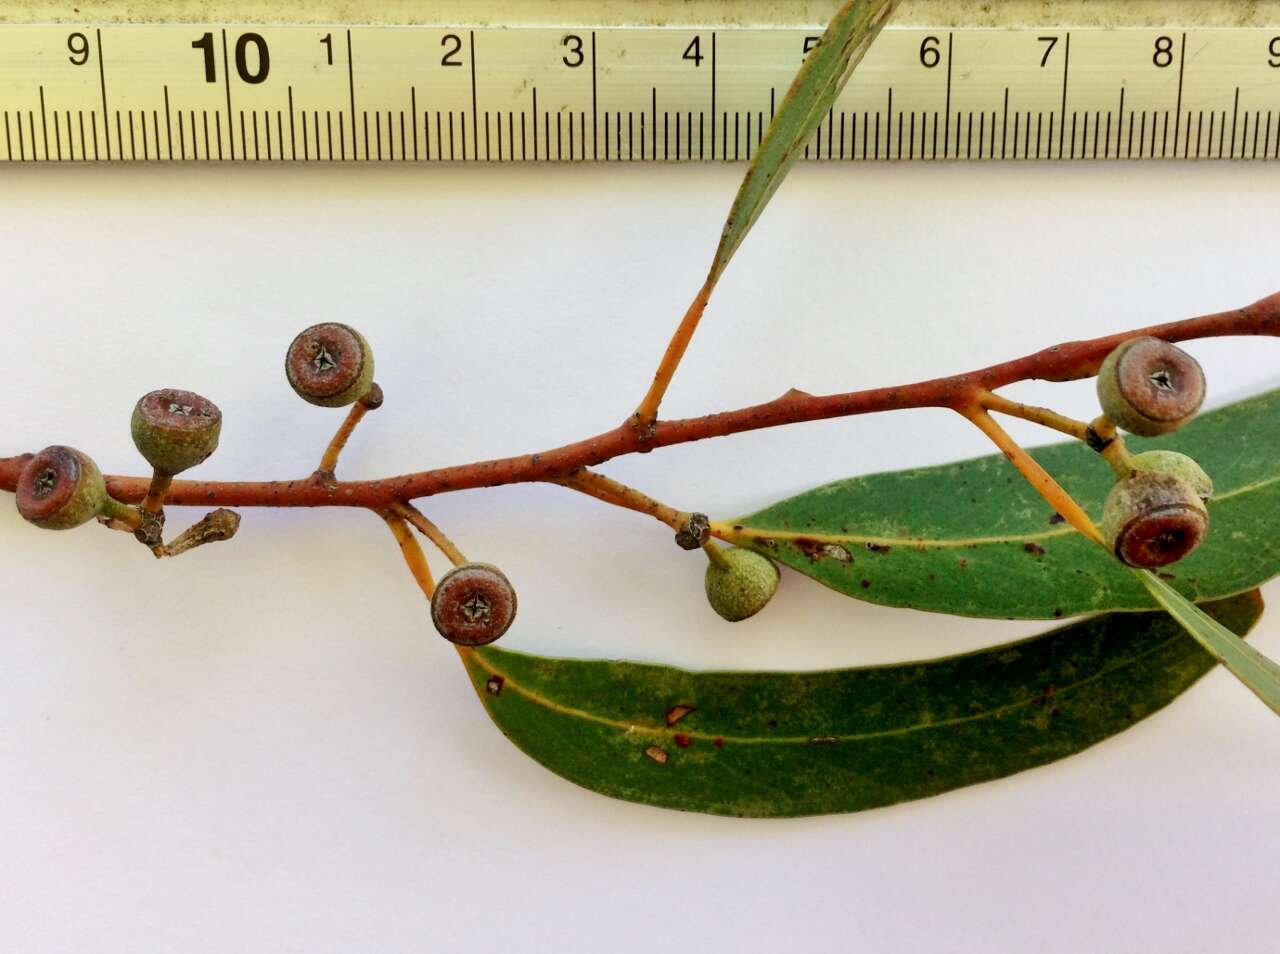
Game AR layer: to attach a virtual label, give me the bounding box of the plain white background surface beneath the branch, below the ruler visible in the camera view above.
[0,152,1280,954]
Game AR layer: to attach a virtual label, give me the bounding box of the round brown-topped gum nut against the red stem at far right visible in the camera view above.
[1097,338,1204,437]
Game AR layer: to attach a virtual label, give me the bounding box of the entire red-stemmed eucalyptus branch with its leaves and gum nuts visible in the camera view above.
[10,0,1280,814]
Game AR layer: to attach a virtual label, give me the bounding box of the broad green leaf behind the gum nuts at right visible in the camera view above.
[717,391,1280,618]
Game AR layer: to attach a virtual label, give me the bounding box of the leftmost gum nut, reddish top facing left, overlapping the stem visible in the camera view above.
[17,446,114,530]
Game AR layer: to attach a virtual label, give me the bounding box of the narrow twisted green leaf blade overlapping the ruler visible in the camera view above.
[708,0,895,284]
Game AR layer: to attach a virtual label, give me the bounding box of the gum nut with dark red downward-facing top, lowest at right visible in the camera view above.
[1102,470,1208,569]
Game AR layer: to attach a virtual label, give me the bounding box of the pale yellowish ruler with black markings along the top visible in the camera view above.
[0,0,1280,163]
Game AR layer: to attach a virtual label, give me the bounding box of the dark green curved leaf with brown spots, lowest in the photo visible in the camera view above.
[462,592,1262,817]
